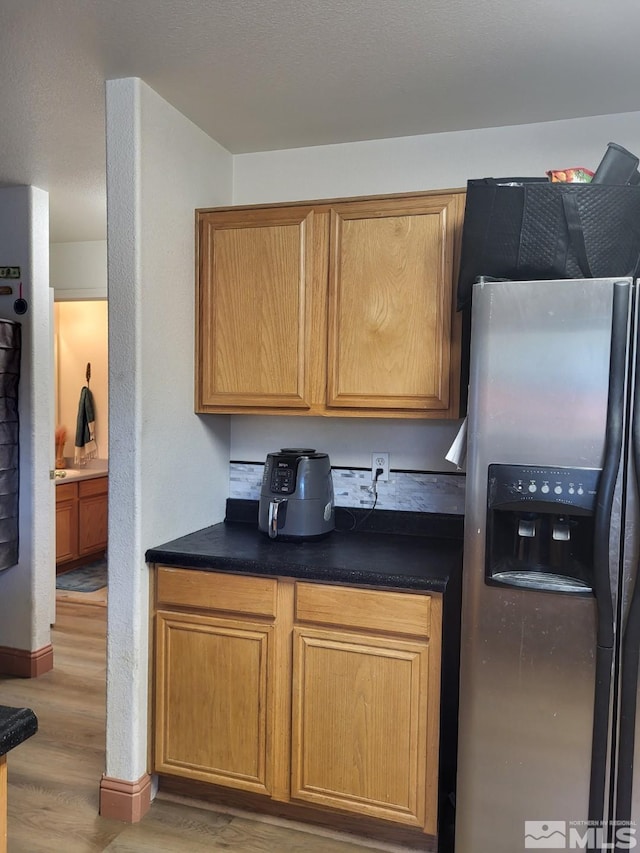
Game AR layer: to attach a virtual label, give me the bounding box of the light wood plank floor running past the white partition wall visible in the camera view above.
[0,600,420,853]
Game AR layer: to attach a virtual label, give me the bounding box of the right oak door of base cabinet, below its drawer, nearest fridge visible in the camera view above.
[291,627,438,831]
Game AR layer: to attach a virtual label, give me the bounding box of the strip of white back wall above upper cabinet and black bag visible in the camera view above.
[233,112,640,204]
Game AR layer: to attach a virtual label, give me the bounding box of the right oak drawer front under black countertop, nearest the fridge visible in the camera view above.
[295,583,431,637]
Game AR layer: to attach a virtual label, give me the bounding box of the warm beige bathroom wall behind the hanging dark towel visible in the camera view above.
[54,299,109,462]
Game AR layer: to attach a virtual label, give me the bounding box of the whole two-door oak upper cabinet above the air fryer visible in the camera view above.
[196,191,464,417]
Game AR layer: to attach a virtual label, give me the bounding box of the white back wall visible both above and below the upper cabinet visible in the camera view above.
[231,112,640,471]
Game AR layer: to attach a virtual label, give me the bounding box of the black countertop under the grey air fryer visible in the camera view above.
[145,501,462,592]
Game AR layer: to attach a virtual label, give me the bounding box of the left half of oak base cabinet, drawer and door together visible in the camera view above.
[153,566,293,799]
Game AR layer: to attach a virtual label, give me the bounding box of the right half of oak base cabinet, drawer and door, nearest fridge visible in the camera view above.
[291,583,440,834]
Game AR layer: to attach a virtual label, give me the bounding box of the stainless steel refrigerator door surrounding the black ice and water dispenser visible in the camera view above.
[456,279,630,853]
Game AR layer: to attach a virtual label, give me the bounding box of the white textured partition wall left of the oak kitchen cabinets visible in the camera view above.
[106,79,232,781]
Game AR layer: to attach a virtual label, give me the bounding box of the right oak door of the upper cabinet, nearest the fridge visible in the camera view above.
[327,193,464,417]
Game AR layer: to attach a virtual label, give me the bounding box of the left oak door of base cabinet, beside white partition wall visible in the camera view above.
[154,611,273,794]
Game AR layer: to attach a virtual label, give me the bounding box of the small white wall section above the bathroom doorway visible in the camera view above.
[49,240,107,301]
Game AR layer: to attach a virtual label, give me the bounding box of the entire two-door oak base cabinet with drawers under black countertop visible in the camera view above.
[153,567,442,835]
